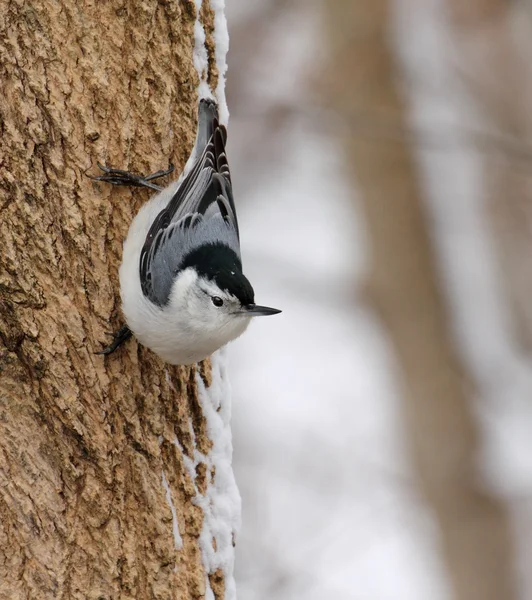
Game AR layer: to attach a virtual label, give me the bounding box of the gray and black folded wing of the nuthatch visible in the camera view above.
[140,118,240,306]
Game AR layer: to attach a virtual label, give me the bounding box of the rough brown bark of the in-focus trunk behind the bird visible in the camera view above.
[0,0,224,600]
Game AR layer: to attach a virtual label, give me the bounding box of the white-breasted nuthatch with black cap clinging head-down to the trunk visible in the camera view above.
[94,99,281,365]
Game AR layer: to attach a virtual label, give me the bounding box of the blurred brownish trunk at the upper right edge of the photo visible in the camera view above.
[447,0,532,344]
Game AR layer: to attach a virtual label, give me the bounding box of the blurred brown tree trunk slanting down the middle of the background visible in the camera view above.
[325,0,515,600]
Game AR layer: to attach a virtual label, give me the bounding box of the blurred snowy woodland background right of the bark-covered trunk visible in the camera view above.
[226,0,532,600]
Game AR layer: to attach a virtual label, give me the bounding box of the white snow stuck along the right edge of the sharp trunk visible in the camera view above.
[162,0,235,600]
